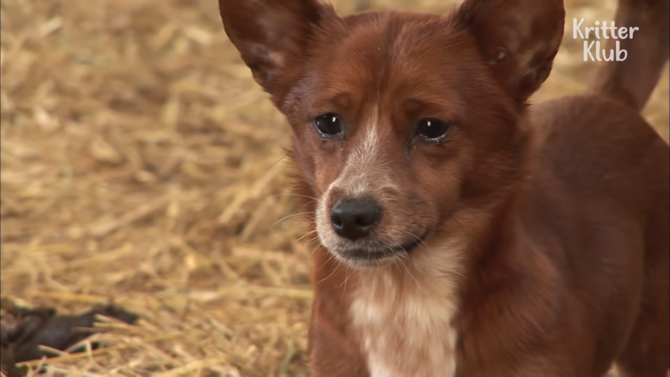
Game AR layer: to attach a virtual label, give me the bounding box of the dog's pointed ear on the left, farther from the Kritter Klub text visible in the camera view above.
[219,0,334,94]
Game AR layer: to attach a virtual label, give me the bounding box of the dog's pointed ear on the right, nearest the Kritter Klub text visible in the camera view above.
[456,0,565,104]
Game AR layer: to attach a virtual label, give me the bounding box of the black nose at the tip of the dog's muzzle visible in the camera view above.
[330,199,382,241]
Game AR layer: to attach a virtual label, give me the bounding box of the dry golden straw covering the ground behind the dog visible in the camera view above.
[0,0,668,376]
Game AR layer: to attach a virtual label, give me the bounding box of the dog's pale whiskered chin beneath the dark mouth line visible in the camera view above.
[330,239,422,268]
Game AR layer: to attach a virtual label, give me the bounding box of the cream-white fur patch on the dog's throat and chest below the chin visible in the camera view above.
[350,239,462,377]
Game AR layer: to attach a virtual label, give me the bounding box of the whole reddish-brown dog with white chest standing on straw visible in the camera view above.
[219,0,670,377]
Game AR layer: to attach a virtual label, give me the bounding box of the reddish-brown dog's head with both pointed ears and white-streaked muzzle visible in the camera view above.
[219,0,564,266]
